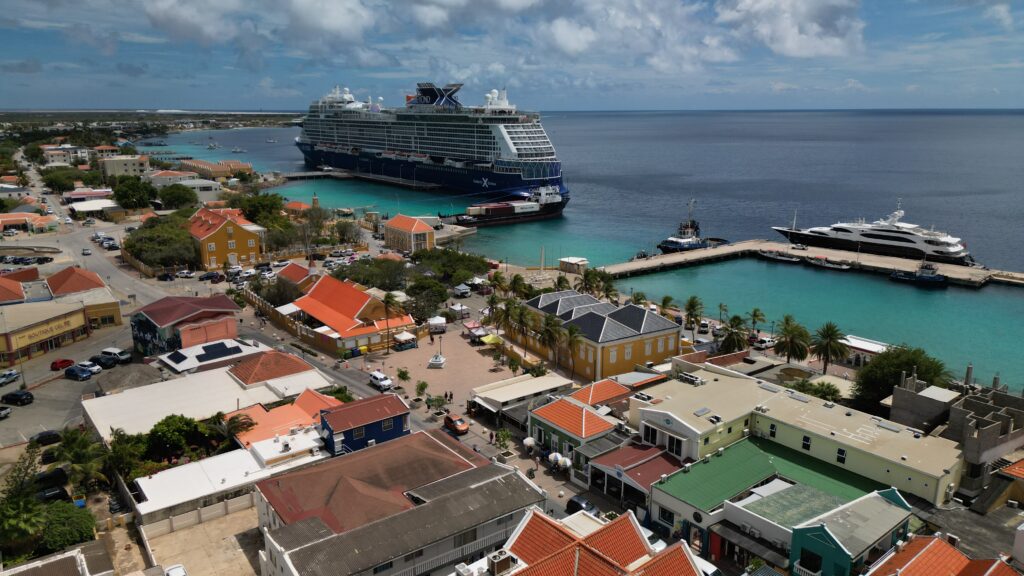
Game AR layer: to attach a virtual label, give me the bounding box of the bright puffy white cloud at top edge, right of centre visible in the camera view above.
[715,0,864,57]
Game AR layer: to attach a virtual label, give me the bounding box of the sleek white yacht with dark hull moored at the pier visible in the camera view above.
[772,203,974,265]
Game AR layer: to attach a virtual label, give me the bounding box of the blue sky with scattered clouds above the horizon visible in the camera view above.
[0,0,1024,110]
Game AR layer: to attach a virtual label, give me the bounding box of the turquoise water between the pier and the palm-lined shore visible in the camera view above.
[618,259,1024,390]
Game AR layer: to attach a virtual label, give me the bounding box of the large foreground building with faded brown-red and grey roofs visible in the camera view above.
[256,429,544,576]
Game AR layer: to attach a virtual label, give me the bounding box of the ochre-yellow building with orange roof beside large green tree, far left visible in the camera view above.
[188,208,266,270]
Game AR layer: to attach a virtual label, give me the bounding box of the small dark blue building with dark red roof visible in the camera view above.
[321,394,409,456]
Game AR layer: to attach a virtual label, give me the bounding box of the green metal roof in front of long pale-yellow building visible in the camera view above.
[654,438,885,511]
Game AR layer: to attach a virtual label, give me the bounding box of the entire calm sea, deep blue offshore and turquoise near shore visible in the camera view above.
[149,112,1024,389]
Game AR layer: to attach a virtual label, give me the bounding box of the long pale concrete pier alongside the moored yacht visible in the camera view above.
[603,240,1024,287]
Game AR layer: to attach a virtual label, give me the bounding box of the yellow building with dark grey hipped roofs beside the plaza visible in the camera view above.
[520,290,681,380]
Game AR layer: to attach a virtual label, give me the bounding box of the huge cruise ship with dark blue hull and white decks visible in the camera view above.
[295,83,568,206]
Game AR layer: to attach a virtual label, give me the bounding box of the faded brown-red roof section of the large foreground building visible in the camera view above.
[256,429,481,533]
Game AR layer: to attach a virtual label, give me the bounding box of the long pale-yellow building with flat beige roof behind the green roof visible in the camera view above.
[629,359,963,505]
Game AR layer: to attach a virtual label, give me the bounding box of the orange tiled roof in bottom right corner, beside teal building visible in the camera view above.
[868,536,1018,576]
